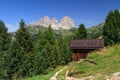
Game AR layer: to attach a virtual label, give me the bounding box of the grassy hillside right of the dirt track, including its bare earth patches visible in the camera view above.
[57,45,120,80]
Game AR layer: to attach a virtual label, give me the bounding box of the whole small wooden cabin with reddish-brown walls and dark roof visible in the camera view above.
[70,39,104,61]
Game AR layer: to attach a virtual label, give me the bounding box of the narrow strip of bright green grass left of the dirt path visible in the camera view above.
[25,66,63,80]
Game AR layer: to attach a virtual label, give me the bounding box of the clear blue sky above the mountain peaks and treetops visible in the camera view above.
[0,0,120,32]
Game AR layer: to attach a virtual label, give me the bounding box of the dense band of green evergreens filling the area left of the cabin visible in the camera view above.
[0,20,72,80]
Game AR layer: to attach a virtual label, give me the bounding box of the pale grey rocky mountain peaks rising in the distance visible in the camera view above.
[30,16,75,30]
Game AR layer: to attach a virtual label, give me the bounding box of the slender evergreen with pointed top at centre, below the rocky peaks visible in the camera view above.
[44,26,57,67]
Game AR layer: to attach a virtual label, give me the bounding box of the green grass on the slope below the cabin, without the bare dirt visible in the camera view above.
[68,45,120,80]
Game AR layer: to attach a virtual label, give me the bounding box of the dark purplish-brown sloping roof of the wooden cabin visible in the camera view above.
[70,39,104,49]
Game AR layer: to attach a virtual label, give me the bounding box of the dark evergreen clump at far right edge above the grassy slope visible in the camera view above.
[103,10,120,45]
